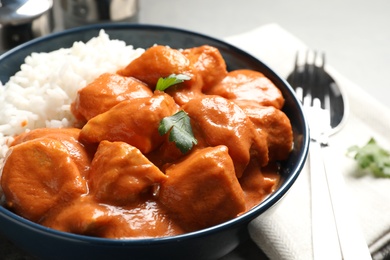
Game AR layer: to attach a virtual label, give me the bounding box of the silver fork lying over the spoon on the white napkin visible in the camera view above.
[290,51,341,259]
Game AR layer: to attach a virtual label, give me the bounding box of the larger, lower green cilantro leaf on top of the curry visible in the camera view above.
[158,110,198,154]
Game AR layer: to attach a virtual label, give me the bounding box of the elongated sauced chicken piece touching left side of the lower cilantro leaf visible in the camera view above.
[80,91,178,154]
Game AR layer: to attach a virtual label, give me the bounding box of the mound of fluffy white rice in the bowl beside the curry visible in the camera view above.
[0,30,144,164]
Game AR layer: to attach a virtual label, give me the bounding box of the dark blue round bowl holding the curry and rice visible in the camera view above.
[0,24,309,260]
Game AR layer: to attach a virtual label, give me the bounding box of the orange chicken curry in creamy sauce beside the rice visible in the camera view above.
[1,45,292,238]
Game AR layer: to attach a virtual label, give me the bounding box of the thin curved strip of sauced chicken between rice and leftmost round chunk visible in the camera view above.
[12,128,92,177]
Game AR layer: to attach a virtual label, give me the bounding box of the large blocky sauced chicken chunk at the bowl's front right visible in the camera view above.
[158,145,245,232]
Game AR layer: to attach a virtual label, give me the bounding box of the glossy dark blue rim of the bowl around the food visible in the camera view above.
[0,23,310,246]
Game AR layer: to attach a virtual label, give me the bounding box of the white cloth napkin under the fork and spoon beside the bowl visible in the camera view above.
[225,24,390,260]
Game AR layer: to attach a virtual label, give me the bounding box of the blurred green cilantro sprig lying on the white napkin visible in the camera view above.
[347,138,390,178]
